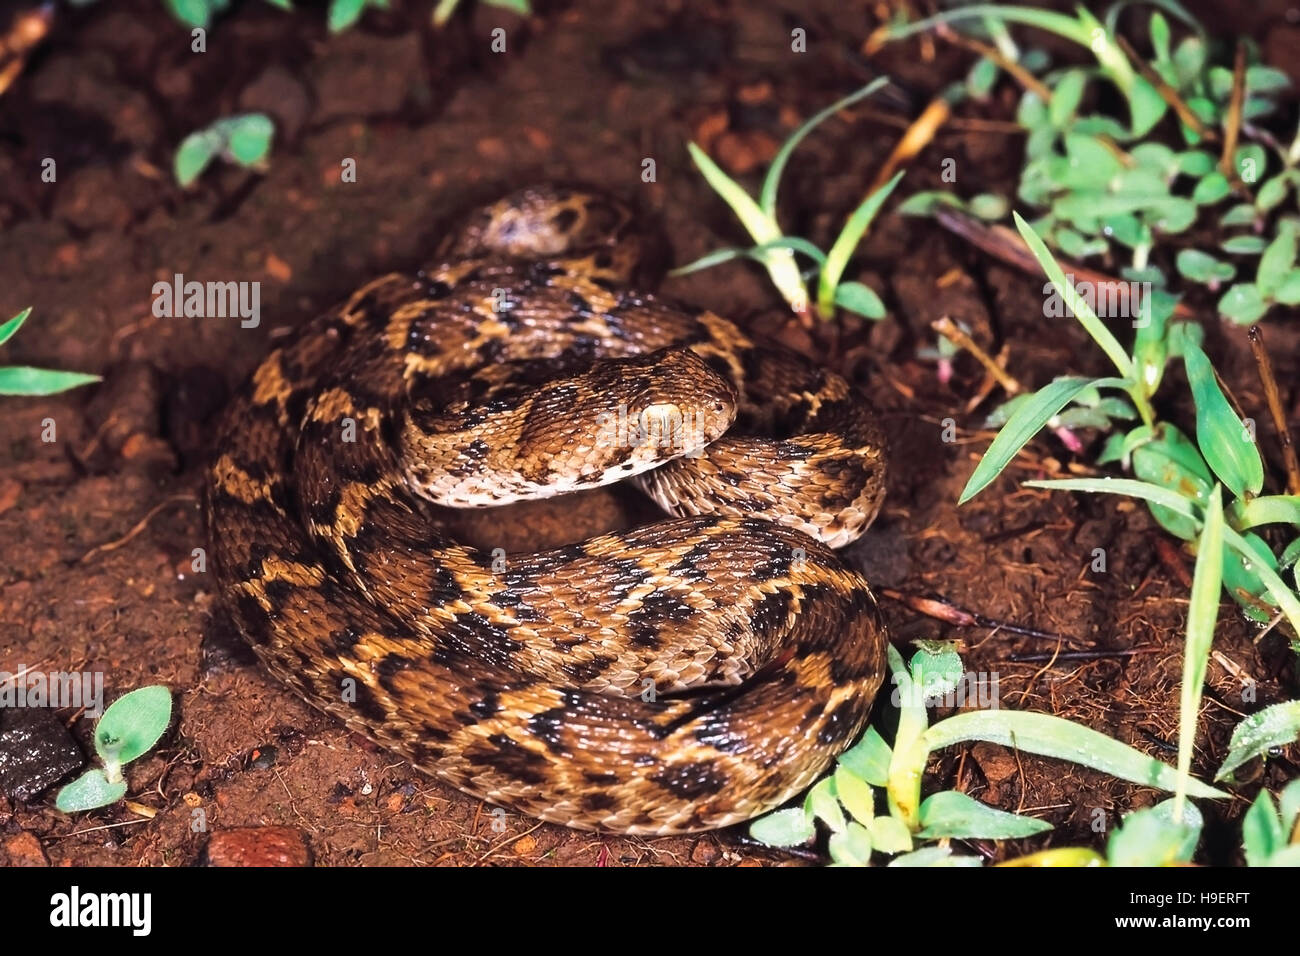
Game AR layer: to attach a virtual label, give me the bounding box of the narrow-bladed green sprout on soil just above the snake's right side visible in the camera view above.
[672,78,902,319]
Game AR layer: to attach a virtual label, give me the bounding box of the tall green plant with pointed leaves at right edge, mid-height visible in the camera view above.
[961,215,1300,635]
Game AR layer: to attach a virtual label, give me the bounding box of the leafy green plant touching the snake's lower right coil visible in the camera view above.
[750,645,1227,866]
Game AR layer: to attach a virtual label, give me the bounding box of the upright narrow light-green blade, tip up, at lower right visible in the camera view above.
[1174,485,1223,817]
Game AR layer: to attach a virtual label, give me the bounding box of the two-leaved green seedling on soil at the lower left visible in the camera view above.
[55,684,172,813]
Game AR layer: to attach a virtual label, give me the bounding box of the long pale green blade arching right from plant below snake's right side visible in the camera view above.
[922,712,1227,797]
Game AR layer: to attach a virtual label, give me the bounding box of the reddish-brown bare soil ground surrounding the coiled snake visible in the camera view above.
[0,0,1300,866]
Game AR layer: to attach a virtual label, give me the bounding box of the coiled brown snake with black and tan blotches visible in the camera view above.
[204,186,885,834]
